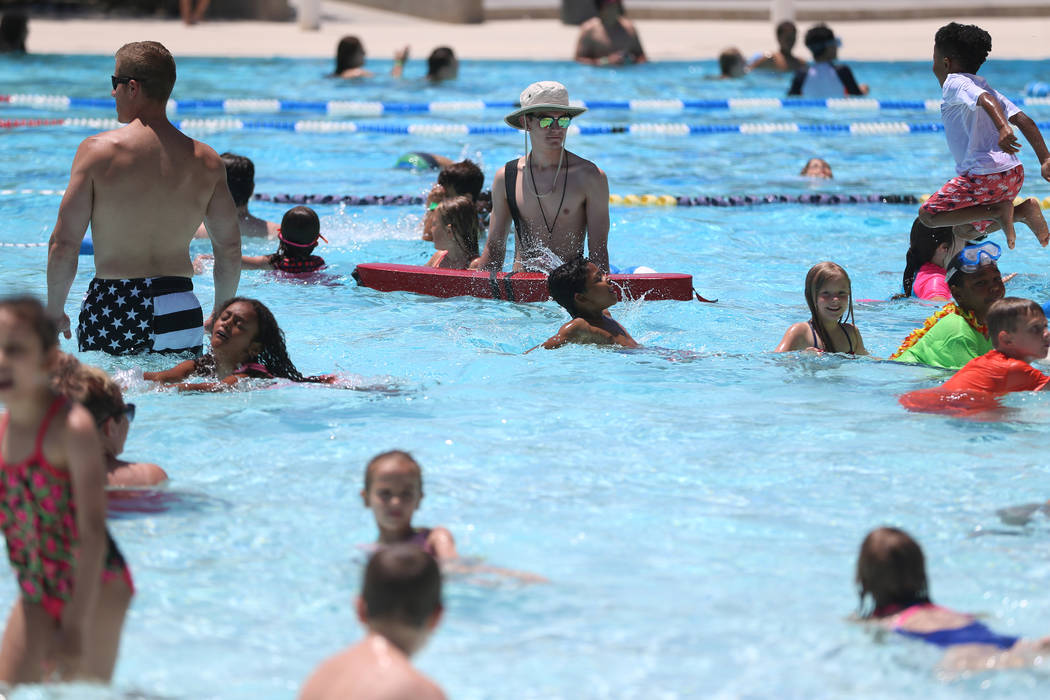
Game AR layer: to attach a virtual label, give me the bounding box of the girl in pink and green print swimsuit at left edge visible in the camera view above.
[0,297,132,683]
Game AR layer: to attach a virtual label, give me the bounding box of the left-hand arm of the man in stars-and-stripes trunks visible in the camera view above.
[47,137,98,338]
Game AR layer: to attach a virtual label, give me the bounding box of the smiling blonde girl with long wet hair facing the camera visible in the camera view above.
[775,262,867,355]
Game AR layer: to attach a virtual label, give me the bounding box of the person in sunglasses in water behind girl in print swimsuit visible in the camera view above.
[51,355,168,488]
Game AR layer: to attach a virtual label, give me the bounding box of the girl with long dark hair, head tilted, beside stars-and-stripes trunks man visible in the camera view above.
[143,297,336,391]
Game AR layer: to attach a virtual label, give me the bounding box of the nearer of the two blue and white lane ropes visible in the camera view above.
[6,118,1033,136]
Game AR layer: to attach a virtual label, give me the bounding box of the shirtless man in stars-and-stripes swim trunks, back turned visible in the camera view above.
[47,41,240,355]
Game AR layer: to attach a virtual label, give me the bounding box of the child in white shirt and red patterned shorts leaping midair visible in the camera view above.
[919,22,1050,248]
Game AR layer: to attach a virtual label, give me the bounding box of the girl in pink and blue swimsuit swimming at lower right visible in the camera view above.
[857,527,1050,671]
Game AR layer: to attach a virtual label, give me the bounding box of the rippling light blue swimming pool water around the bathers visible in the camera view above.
[0,51,1050,698]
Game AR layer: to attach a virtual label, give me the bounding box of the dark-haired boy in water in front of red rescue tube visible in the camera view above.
[528,256,639,352]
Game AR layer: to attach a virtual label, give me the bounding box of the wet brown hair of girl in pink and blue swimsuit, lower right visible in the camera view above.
[857,527,930,617]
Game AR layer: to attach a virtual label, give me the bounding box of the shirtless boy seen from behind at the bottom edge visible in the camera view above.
[299,544,445,700]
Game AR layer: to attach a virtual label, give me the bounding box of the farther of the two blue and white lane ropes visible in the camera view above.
[6,94,1050,116]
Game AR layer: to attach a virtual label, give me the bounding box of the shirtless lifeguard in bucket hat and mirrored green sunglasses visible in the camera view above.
[480,81,609,272]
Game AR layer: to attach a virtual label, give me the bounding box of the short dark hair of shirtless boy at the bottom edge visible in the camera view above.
[361,544,441,628]
